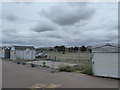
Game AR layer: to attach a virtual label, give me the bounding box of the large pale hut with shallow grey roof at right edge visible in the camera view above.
[92,43,120,78]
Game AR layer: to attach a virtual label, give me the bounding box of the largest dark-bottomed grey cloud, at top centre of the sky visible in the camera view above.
[40,3,95,25]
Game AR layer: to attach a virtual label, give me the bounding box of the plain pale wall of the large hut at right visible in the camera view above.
[93,53,118,78]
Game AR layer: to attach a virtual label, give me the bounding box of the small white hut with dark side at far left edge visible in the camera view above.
[0,46,10,58]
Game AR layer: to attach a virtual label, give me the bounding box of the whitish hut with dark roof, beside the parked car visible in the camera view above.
[10,46,35,60]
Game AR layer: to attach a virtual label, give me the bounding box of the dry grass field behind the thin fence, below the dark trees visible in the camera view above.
[46,51,92,62]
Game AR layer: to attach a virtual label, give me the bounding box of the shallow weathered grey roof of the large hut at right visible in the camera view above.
[92,43,120,53]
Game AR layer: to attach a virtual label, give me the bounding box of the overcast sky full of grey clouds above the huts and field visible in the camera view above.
[0,2,118,47]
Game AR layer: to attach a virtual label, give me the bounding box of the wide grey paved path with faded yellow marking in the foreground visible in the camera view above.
[2,60,118,88]
